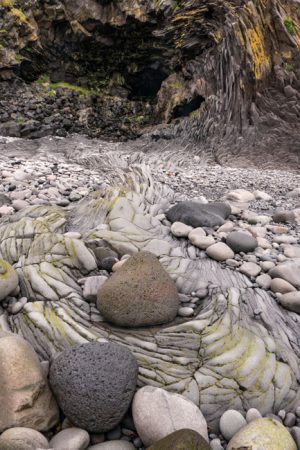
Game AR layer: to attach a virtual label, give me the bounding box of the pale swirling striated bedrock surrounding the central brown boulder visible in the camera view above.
[0,167,300,426]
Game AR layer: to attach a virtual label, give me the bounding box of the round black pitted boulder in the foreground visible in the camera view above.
[49,342,138,433]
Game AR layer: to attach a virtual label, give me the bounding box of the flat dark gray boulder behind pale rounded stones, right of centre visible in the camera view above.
[166,202,231,228]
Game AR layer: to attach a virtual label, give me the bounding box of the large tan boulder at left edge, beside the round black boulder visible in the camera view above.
[0,334,58,431]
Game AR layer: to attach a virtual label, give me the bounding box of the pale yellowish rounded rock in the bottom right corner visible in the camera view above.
[227,418,297,450]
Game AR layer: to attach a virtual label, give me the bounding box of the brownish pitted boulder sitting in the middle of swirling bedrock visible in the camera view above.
[97,252,179,327]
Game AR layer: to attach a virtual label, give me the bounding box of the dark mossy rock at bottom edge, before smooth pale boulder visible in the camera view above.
[147,429,211,450]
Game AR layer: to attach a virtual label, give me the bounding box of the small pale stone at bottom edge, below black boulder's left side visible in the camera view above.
[49,427,90,450]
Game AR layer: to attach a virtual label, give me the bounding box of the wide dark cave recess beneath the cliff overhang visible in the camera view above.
[18,17,174,101]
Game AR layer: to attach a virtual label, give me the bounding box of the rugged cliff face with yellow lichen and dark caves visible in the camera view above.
[0,0,300,163]
